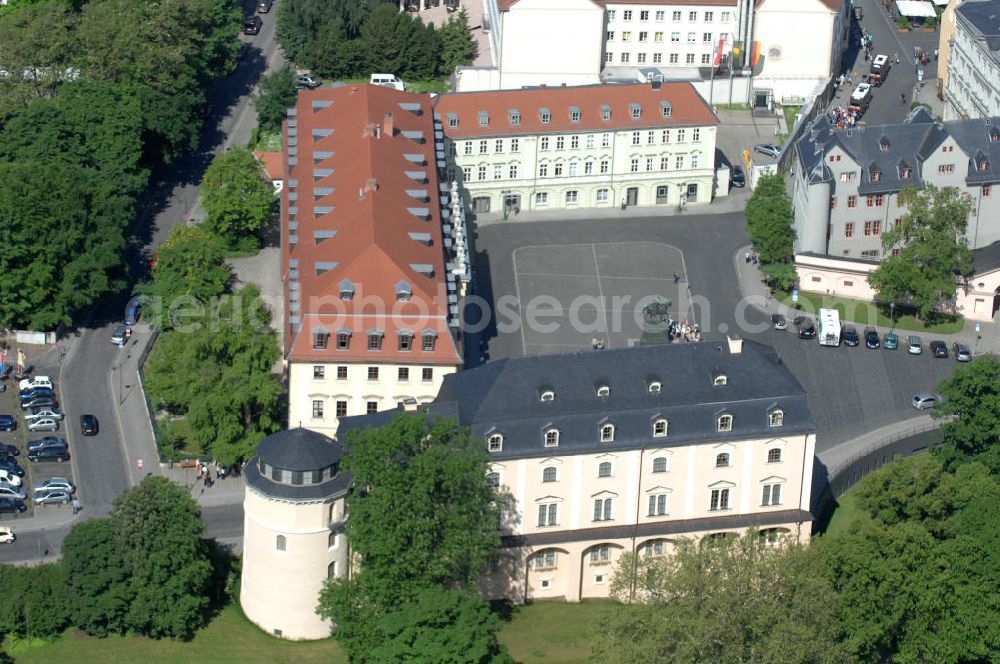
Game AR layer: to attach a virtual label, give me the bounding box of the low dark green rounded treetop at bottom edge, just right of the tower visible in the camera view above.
[369,588,514,664]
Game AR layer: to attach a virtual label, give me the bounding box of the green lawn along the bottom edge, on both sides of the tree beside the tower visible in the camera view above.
[4,602,609,664]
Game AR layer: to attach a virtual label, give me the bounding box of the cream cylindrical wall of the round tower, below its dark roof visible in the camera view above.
[240,484,349,640]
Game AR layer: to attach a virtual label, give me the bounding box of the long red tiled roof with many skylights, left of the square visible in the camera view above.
[281,85,461,365]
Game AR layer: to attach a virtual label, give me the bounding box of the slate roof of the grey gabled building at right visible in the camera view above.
[795,106,1000,189]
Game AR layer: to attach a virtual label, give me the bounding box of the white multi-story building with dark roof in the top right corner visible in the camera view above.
[944,0,1000,120]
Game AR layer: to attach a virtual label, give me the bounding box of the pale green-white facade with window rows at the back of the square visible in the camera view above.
[447,126,716,213]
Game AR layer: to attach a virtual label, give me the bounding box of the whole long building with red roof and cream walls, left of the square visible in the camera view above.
[281,85,469,434]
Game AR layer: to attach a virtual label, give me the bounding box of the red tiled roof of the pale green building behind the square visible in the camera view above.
[435,83,719,138]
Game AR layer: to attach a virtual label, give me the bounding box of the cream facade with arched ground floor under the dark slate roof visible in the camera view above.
[484,428,816,601]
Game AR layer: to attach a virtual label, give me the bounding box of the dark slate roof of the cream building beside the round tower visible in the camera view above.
[435,341,816,459]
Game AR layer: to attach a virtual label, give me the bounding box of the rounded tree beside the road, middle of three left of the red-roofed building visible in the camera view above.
[139,224,232,330]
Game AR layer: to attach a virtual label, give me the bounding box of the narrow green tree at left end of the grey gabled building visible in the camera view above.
[744,173,795,289]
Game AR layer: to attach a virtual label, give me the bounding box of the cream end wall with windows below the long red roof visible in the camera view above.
[288,362,458,435]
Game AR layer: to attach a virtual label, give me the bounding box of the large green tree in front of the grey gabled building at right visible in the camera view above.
[868,185,972,318]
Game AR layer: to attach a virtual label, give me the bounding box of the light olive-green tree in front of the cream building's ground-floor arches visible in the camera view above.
[593,532,851,664]
